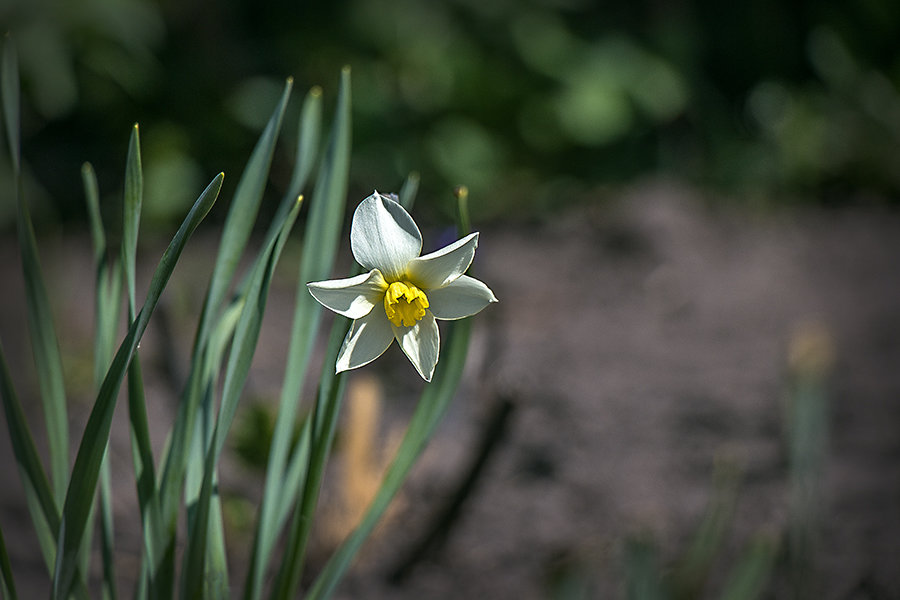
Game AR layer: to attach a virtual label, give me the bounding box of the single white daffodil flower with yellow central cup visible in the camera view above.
[307,191,497,381]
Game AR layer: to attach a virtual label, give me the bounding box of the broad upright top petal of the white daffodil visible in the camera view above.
[350,192,422,281]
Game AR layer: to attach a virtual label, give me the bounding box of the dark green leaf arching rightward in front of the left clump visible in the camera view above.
[53,174,223,600]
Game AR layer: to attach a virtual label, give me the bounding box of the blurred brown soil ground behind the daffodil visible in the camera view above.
[0,184,900,599]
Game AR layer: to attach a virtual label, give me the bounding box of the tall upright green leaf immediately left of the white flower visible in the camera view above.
[245,68,351,600]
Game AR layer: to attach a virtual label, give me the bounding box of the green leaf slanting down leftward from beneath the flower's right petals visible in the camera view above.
[302,319,471,600]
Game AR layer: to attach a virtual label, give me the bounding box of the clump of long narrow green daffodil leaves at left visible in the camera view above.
[0,35,469,600]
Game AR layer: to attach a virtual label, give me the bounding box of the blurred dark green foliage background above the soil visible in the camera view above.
[0,0,900,228]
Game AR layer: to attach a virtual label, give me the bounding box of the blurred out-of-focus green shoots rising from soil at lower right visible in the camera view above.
[550,346,833,600]
